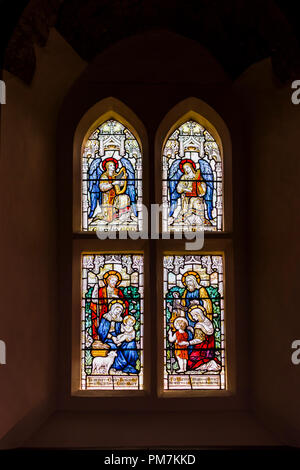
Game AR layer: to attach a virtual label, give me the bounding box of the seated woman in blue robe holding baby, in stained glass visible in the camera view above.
[98,300,139,374]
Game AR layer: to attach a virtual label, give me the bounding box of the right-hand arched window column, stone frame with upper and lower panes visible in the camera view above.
[156,98,234,396]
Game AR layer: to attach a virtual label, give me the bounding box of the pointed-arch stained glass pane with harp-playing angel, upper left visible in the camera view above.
[82,119,142,231]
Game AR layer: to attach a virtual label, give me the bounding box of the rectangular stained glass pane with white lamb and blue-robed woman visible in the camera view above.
[81,253,144,390]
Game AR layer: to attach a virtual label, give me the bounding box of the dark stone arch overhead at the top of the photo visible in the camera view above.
[4,0,300,83]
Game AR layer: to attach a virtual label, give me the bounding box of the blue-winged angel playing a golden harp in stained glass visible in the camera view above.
[88,157,137,224]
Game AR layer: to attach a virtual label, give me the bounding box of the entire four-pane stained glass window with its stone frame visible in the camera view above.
[73,100,234,396]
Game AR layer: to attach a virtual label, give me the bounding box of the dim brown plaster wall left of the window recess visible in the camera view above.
[0,30,84,445]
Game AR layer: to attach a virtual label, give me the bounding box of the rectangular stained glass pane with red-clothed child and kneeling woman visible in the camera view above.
[164,254,225,390]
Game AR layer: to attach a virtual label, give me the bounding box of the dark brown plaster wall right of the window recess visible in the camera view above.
[234,60,300,445]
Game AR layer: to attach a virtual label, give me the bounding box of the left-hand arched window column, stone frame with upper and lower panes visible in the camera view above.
[72,98,148,395]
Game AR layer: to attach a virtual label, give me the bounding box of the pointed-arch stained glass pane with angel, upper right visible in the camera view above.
[162,120,223,232]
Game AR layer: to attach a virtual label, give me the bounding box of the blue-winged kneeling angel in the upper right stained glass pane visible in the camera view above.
[169,158,214,226]
